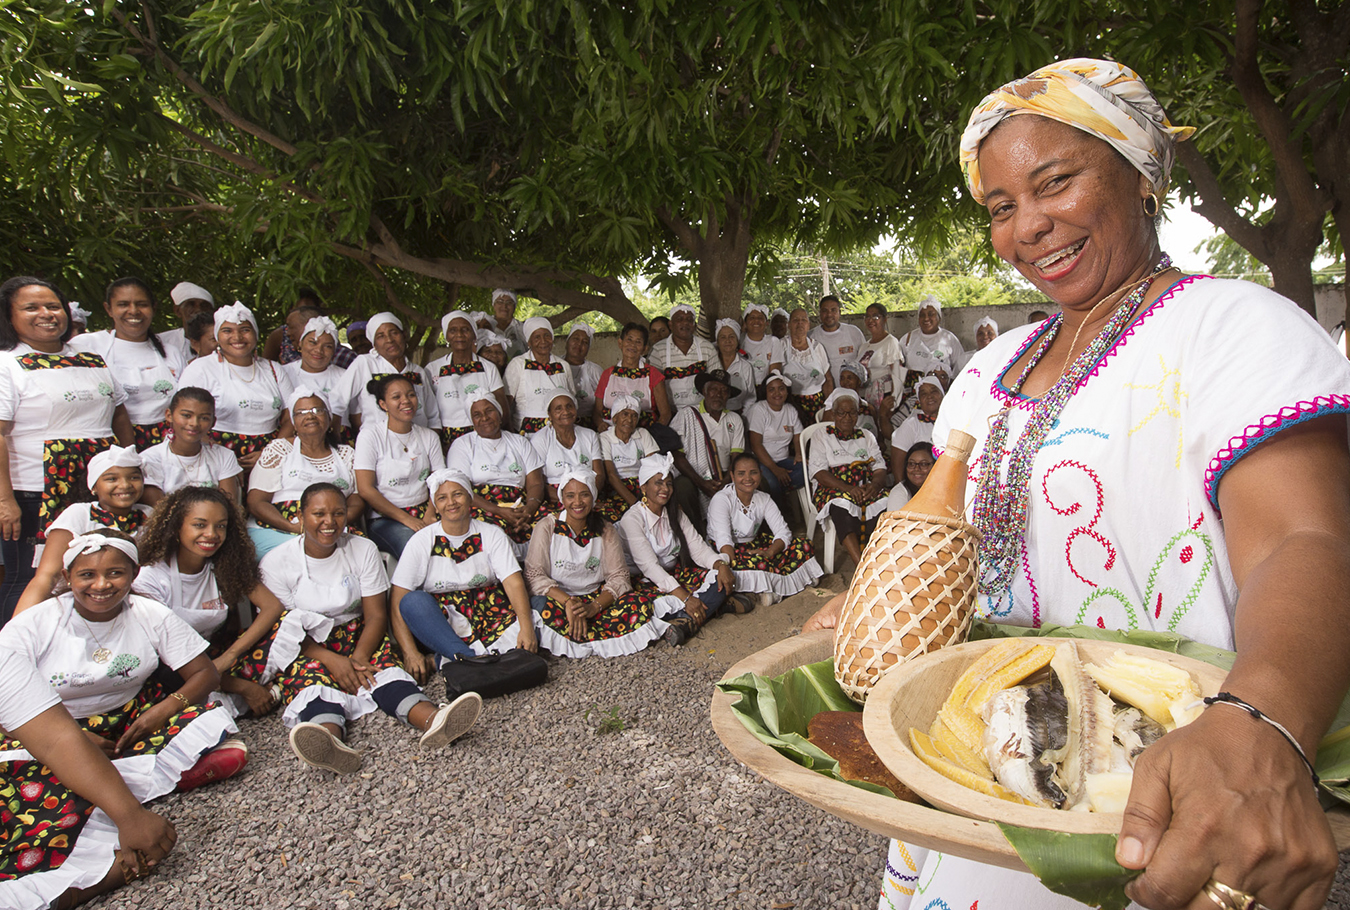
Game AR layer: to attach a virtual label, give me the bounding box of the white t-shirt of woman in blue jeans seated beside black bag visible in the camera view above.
[393,521,520,594]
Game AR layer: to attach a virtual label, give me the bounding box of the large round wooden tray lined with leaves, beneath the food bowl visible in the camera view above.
[711,629,1350,871]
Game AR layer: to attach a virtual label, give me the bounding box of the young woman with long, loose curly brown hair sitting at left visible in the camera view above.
[132,486,282,717]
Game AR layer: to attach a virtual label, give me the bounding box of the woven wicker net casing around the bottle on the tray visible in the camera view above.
[834,510,980,703]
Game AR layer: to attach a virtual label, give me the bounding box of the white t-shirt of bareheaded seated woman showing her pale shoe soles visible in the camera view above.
[258,533,389,622]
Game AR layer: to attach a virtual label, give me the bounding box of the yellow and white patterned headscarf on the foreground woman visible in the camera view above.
[961,57,1195,204]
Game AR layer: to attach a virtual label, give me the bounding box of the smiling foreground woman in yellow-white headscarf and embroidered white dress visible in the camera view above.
[805,59,1350,910]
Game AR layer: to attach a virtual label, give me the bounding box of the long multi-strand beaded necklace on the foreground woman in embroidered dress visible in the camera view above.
[971,254,1172,593]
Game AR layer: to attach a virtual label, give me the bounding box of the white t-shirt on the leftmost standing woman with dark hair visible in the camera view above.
[0,344,127,490]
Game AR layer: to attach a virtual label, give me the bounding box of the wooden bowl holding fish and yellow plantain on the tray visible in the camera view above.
[863,639,1229,834]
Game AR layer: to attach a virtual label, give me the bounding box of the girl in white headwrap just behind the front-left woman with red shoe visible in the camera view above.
[15,446,150,613]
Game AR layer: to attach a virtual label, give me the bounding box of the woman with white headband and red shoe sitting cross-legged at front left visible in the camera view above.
[0,528,248,820]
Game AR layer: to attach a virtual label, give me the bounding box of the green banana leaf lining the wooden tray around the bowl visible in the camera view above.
[717,620,1350,910]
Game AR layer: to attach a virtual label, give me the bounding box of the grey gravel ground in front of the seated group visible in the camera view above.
[88,567,1350,910]
